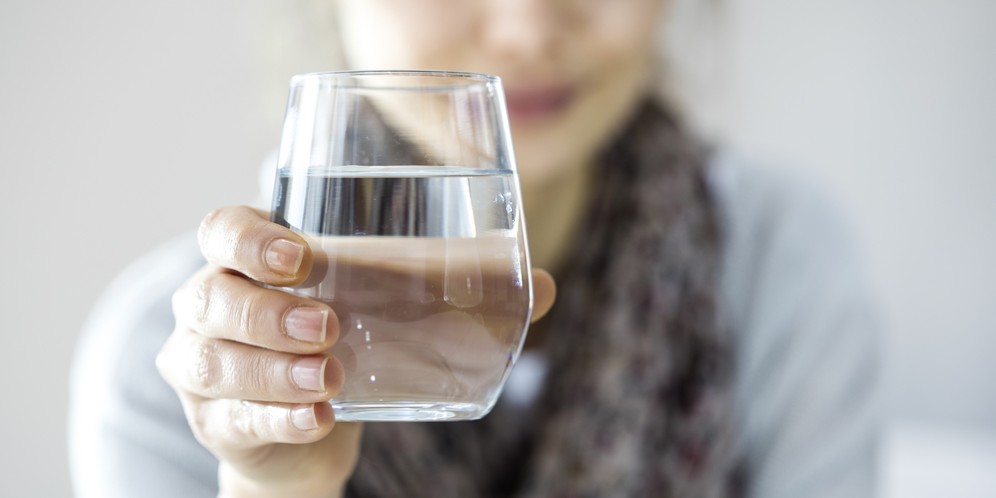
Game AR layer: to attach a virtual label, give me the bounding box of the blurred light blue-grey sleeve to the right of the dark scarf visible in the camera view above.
[711,157,881,498]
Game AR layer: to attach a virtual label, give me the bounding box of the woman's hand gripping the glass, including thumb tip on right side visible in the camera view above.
[156,207,555,497]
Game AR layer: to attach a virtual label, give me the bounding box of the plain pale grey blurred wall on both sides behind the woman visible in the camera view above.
[0,0,996,498]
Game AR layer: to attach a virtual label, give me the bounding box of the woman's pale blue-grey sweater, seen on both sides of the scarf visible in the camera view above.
[69,156,880,498]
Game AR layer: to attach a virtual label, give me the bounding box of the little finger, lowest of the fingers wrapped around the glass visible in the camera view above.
[180,393,335,456]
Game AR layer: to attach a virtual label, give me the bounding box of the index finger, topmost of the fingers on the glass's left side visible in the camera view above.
[197,206,311,286]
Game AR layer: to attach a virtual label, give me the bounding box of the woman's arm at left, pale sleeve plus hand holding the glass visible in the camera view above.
[71,208,554,498]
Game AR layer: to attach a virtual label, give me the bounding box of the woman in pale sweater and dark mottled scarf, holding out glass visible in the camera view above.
[72,0,875,497]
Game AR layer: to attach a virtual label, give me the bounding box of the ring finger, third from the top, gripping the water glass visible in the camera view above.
[156,330,344,403]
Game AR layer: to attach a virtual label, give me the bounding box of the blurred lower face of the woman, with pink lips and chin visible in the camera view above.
[338,0,663,188]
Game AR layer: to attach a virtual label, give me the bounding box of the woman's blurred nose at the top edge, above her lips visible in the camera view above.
[482,0,567,59]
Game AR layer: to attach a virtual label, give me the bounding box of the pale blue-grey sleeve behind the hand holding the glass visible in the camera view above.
[68,235,218,498]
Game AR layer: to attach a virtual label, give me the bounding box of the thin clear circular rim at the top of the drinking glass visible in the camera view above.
[290,69,501,91]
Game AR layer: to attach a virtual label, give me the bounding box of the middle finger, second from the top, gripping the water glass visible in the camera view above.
[173,266,339,354]
